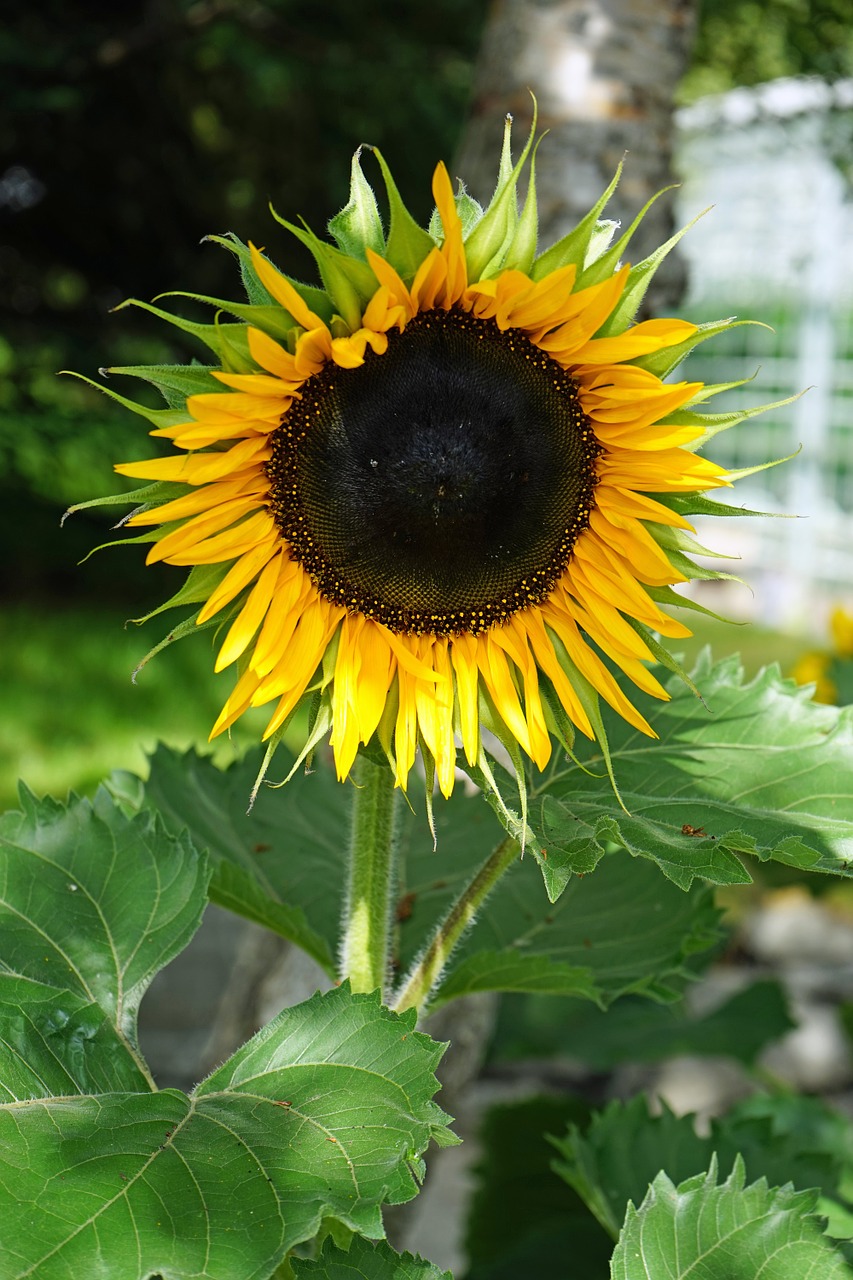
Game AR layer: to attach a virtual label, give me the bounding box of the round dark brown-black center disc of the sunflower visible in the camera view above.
[268,310,601,635]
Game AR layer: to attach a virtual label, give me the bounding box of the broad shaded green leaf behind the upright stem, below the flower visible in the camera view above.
[137,748,716,1004]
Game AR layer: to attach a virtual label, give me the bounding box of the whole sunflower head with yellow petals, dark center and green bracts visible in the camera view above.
[81,120,745,796]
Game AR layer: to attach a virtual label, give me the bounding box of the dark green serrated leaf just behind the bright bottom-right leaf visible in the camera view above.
[551,1094,839,1239]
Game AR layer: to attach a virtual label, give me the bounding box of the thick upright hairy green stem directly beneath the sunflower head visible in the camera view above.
[341,755,398,995]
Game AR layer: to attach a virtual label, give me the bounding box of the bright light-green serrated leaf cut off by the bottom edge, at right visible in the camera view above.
[611,1158,853,1280]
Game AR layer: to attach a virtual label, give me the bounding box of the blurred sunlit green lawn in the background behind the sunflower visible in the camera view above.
[0,604,804,808]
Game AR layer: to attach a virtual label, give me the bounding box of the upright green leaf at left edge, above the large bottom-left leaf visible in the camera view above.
[0,790,209,1101]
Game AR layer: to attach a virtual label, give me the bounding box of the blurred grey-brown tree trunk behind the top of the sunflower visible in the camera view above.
[456,0,695,311]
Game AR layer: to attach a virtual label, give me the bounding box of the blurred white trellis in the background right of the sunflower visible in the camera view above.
[678,78,853,632]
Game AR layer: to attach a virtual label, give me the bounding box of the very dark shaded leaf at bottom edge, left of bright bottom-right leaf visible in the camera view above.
[465,1096,612,1280]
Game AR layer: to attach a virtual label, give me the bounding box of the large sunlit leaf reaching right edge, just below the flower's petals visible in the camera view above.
[525,655,853,896]
